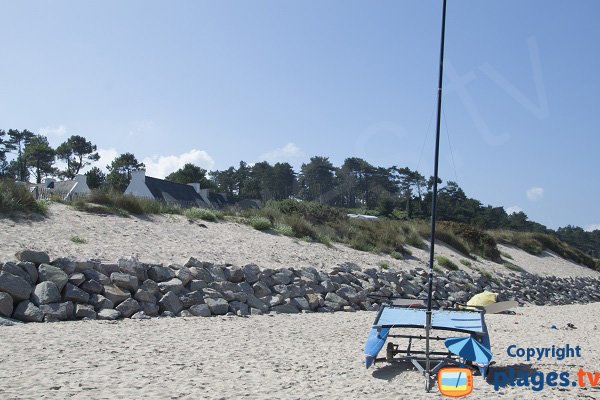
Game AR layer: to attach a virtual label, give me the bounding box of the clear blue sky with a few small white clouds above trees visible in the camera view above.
[0,0,600,229]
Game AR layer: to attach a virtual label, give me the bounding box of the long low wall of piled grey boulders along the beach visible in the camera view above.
[0,250,600,325]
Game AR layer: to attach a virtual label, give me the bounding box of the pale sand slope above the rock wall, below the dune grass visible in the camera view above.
[0,204,599,276]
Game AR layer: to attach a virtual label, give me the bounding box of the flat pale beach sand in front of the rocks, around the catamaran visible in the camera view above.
[0,304,600,400]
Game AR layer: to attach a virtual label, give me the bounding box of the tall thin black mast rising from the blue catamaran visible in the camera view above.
[425,0,446,391]
